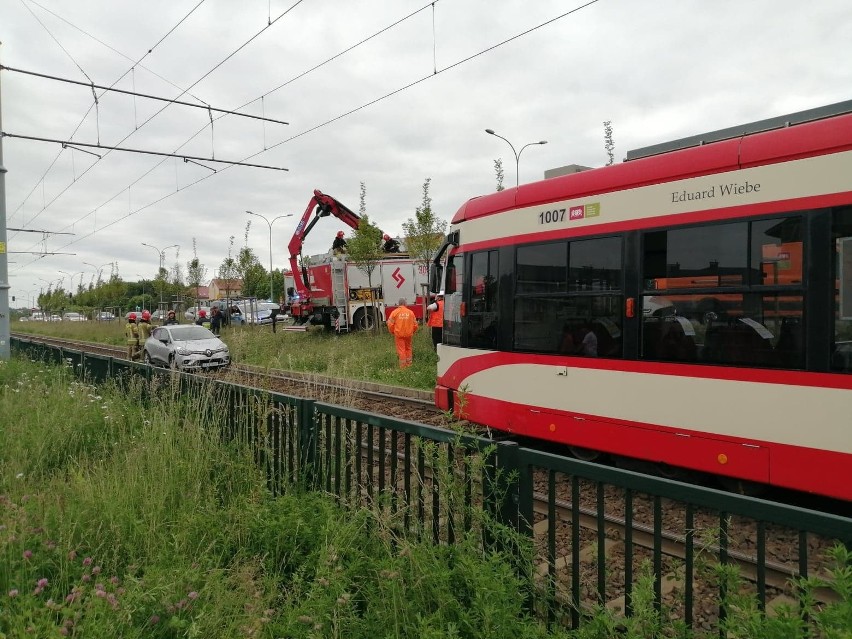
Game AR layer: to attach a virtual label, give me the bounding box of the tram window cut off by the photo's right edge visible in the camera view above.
[831,207,852,373]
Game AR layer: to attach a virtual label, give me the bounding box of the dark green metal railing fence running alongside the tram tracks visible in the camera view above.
[12,337,852,634]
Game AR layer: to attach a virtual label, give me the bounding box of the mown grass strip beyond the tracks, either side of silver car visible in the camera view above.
[12,321,438,390]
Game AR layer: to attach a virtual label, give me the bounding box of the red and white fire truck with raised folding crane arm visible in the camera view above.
[288,190,429,332]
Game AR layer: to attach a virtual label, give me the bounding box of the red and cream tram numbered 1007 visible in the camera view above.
[433,101,852,500]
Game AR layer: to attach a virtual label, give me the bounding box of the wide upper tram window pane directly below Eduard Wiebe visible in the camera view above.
[643,222,748,289]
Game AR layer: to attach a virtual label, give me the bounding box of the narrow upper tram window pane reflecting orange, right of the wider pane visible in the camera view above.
[751,217,802,286]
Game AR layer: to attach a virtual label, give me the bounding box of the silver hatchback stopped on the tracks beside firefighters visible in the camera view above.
[143,324,231,370]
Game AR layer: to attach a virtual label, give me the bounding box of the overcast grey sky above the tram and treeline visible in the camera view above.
[0,0,852,306]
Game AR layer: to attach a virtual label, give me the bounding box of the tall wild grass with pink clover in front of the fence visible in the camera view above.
[0,360,852,639]
